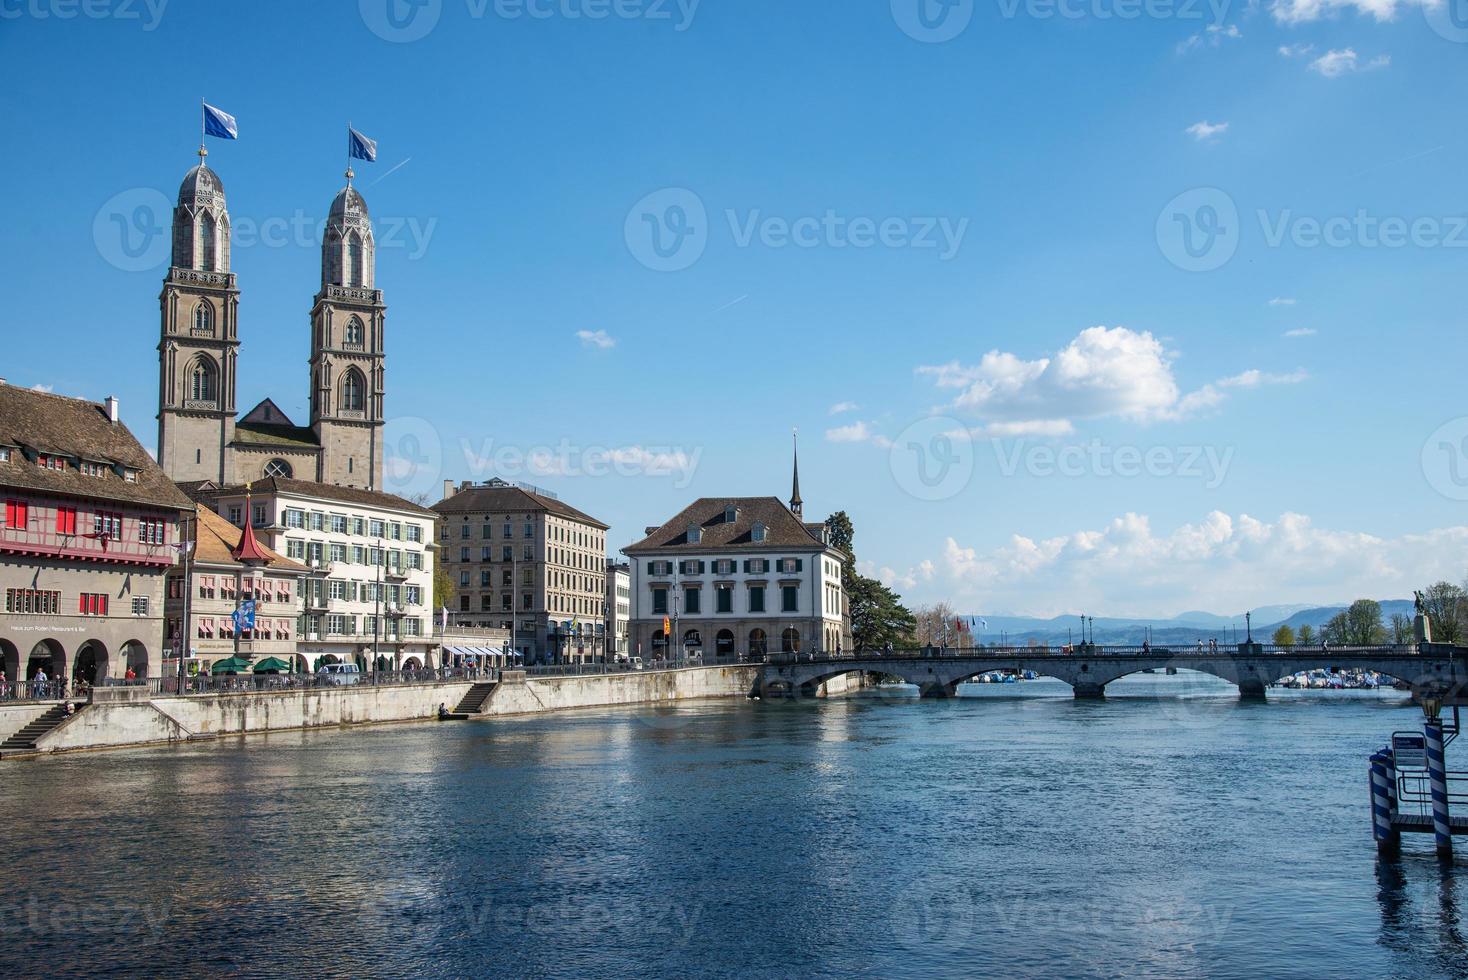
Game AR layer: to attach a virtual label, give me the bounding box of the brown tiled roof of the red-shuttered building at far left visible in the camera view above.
[0,384,194,511]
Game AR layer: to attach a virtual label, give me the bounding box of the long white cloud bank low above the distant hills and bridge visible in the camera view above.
[932,511,1468,616]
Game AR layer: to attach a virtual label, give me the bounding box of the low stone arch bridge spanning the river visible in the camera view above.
[755,644,1468,704]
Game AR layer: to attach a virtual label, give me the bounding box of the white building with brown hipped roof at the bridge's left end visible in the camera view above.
[624,457,851,660]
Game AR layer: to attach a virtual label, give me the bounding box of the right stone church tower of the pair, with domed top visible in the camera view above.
[311,170,388,490]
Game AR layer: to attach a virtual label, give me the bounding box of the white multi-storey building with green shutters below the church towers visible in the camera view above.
[185,478,439,670]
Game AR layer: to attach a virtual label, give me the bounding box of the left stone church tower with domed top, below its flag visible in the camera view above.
[159,148,239,483]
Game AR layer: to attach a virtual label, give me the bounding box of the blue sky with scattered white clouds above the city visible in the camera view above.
[0,0,1468,615]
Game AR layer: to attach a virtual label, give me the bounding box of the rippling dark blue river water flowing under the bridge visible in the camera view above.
[0,673,1468,979]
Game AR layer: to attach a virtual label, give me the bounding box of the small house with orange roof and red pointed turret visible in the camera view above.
[163,508,310,676]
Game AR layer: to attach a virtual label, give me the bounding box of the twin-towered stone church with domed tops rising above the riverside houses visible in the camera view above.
[159,151,388,490]
